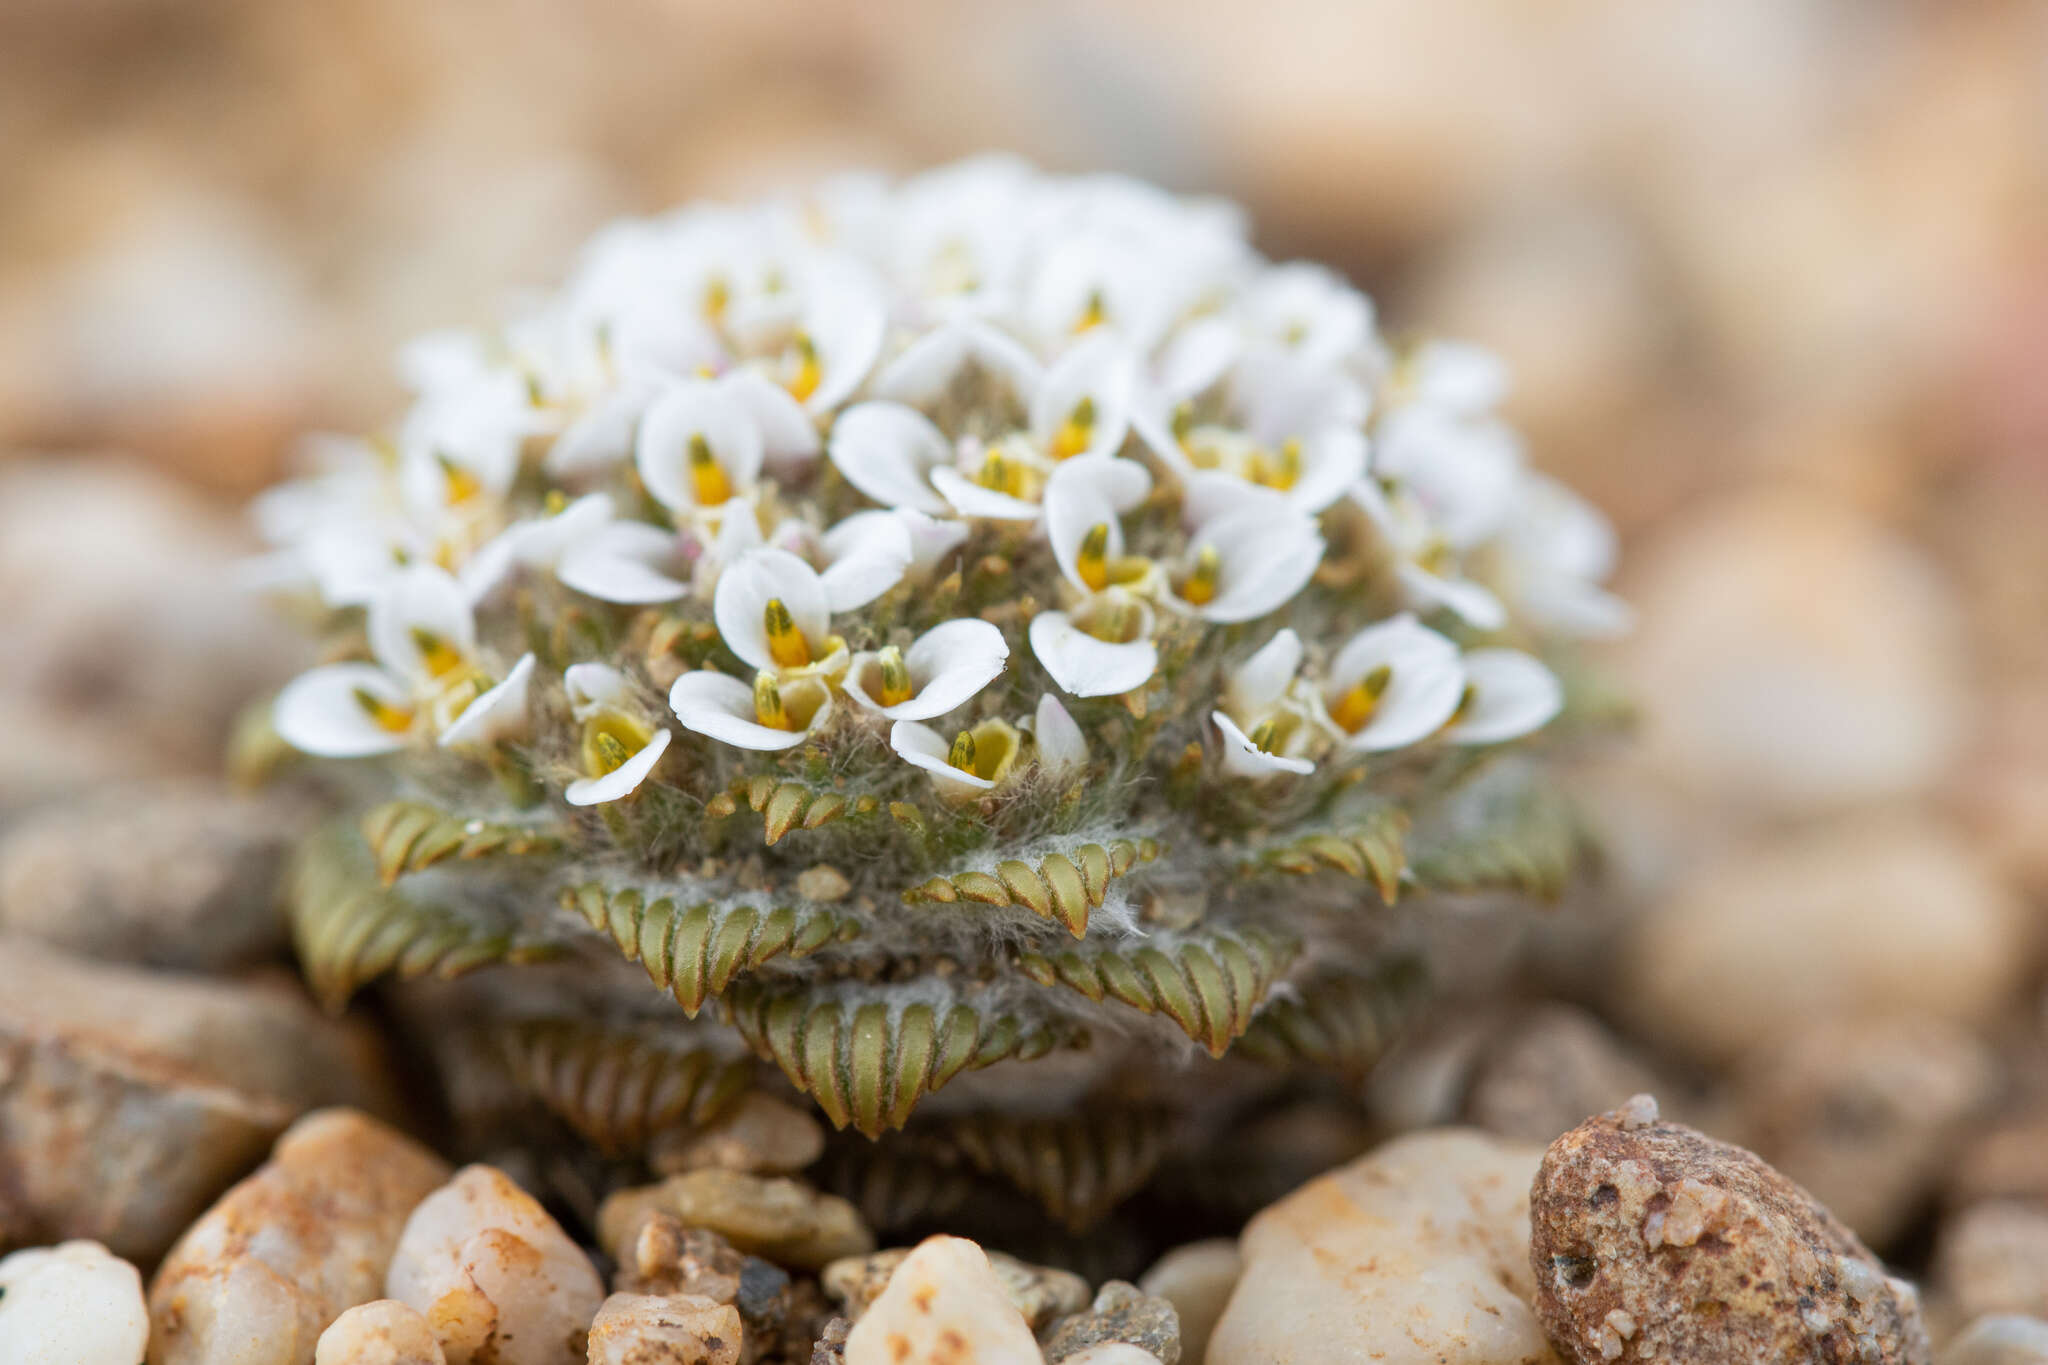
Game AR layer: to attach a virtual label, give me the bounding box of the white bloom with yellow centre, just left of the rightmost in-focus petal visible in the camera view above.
[1319,612,1466,753]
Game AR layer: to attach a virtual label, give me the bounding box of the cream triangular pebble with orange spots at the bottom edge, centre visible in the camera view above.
[846,1236,1044,1365]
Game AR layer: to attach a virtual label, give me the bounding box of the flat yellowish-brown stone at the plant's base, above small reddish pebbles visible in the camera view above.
[598,1171,874,1271]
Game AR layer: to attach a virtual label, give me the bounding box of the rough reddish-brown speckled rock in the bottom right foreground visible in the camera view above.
[1530,1095,1931,1365]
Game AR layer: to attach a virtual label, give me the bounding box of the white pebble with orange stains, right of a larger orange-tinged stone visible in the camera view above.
[385,1166,604,1365]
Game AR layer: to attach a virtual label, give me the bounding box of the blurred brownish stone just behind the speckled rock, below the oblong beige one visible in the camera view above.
[1729,1015,1999,1246]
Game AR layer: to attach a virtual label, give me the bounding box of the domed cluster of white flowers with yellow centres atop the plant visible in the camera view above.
[258,160,1626,806]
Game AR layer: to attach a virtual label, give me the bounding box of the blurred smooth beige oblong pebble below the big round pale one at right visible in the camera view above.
[1612,810,2032,1060]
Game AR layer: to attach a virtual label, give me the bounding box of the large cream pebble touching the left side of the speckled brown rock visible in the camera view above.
[1204,1130,1554,1365]
